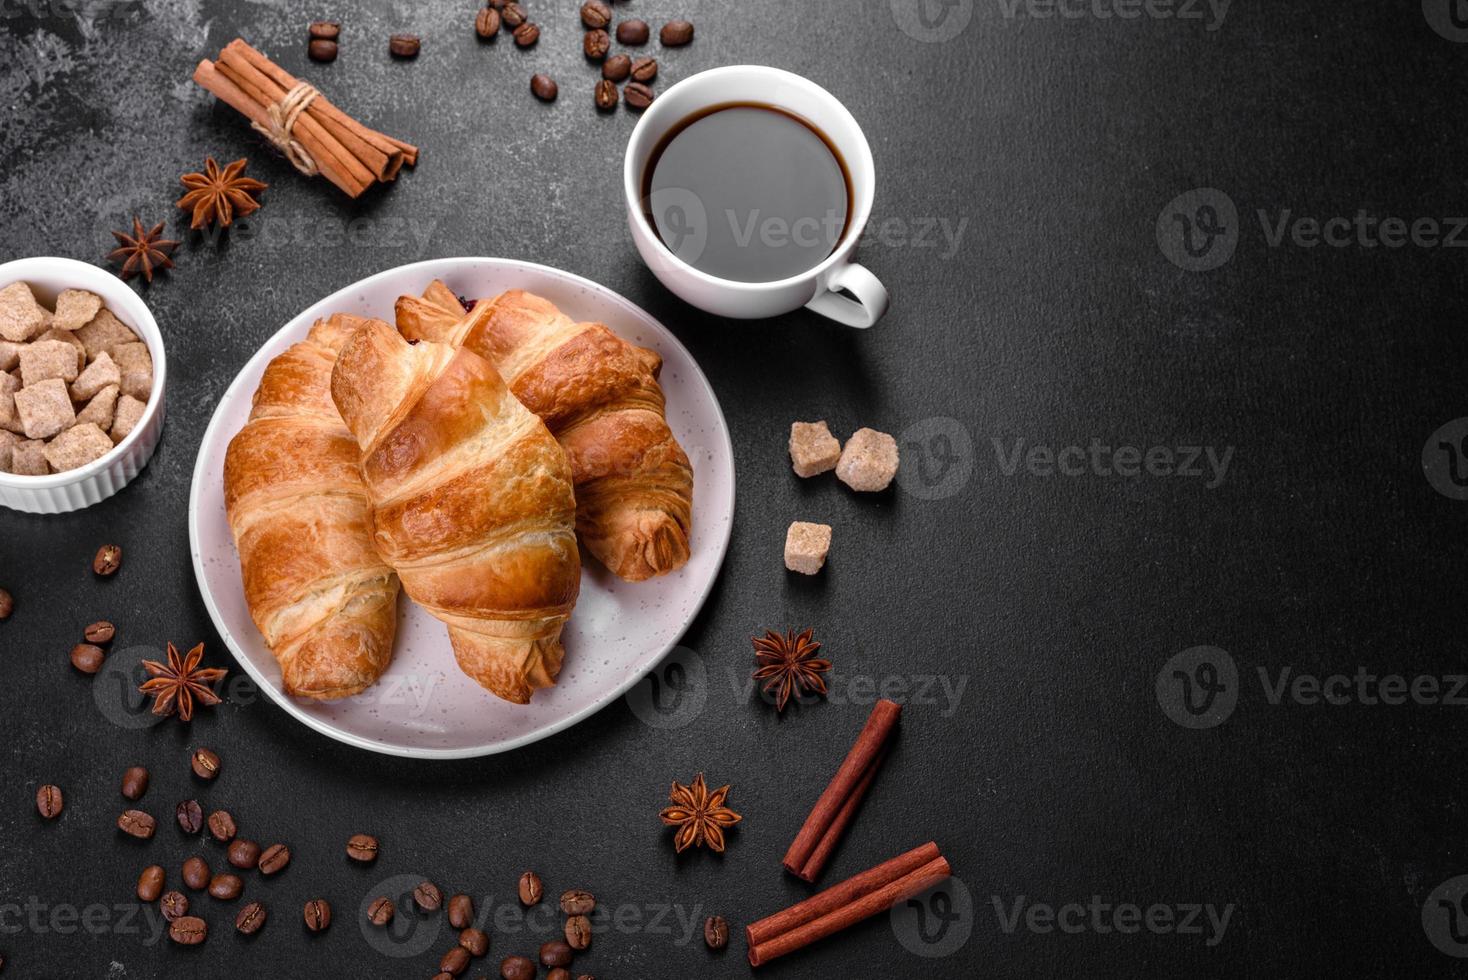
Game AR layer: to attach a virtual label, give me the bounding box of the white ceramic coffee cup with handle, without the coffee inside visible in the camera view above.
[622,65,887,327]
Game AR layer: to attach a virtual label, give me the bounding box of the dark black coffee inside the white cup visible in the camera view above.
[642,103,853,283]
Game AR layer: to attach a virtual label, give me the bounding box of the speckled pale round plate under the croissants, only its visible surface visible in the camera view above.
[189,258,734,758]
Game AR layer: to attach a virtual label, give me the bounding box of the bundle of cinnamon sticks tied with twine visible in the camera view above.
[194,38,418,198]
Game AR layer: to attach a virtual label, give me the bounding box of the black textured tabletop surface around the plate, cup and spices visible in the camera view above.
[0,0,1468,979]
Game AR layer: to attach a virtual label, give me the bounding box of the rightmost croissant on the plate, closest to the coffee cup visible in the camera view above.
[396,280,693,582]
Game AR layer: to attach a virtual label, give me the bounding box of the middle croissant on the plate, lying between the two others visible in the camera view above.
[332,320,581,704]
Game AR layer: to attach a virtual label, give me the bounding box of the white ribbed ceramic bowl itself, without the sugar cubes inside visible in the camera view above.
[0,257,167,513]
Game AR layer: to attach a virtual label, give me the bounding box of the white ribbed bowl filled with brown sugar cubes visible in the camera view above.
[0,258,164,513]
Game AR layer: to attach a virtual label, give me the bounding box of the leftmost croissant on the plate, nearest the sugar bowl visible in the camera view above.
[225,315,398,700]
